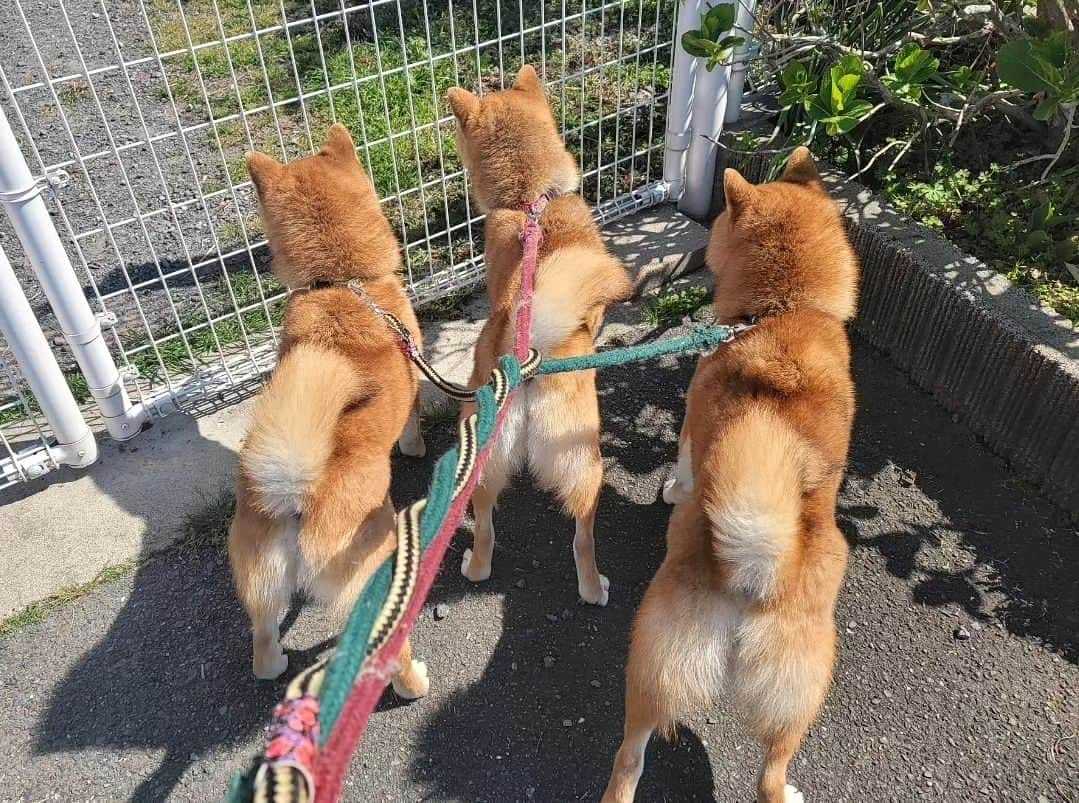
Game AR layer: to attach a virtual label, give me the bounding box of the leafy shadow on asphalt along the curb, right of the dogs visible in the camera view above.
[839,344,1079,663]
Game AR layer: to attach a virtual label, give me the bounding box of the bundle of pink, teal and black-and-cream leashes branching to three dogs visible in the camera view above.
[235,180,742,803]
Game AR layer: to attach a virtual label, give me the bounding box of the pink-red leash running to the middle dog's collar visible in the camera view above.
[315,195,548,803]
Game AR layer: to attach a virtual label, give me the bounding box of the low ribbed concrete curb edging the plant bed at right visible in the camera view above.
[713,154,1079,518]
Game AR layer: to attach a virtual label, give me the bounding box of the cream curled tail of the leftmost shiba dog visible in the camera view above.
[240,344,364,516]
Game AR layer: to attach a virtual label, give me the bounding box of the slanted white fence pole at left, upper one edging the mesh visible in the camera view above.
[0,103,147,440]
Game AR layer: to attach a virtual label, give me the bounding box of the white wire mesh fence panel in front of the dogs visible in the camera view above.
[0,0,678,479]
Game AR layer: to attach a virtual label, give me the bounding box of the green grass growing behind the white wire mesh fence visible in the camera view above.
[39,0,675,410]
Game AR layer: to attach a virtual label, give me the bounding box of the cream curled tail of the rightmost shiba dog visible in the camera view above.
[698,407,824,601]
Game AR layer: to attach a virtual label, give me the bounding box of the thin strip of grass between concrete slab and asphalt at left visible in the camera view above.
[0,491,236,638]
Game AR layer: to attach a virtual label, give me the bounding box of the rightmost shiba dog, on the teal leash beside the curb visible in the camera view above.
[603,149,858,803]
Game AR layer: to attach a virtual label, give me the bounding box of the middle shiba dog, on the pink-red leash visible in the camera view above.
[449,66,632,604]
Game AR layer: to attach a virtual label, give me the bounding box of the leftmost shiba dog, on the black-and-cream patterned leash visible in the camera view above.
[229,124,427,697]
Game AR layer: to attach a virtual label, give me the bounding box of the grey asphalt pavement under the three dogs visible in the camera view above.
[0,315,1079,803]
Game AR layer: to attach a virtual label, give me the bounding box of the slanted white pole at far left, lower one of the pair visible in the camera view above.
[0,241,97,476]
